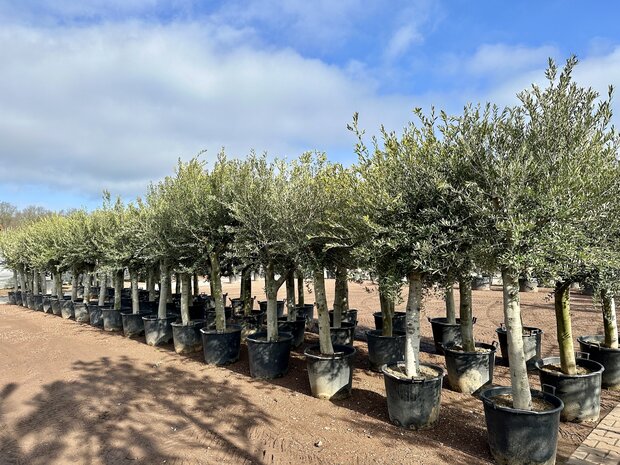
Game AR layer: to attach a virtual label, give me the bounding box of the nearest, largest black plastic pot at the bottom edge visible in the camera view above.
[480,387,564,465]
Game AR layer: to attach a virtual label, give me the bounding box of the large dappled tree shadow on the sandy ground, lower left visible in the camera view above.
[0,356,272,465]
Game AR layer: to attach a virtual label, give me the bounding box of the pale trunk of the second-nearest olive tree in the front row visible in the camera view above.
[405,273,422,378]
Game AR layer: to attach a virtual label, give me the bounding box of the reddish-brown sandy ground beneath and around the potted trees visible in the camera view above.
[0,281,620,465]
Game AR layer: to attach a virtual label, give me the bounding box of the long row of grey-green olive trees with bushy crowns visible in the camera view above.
[0,59,620,409]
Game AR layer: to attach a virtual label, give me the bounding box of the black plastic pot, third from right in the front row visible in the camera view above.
[304,345,355,400]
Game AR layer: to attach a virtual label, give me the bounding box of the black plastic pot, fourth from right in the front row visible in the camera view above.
[246,331,293,379]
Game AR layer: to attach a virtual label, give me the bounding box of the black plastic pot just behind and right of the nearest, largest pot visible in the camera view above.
[536,357,605,422]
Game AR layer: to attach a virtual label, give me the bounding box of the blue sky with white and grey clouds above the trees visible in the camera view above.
[0,0,620,209]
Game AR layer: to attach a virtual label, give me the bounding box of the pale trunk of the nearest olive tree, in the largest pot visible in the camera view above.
[502,270,532,410]
